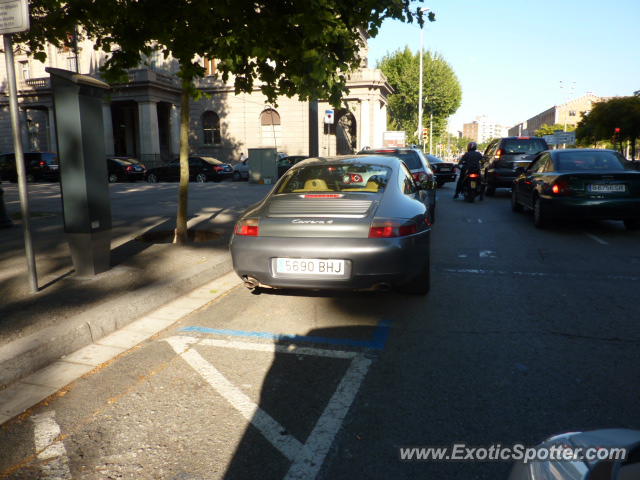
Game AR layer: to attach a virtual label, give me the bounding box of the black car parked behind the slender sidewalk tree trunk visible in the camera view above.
[145,156,233,183]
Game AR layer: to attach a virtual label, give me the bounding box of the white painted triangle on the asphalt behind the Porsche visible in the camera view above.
[165,336,371,480]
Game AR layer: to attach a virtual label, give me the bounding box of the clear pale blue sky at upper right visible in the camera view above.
[369,0,640,132]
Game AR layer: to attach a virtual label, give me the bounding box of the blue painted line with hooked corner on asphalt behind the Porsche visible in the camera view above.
[180,320,391,350]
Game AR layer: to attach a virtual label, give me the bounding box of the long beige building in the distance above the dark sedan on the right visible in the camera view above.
[509,93,606,136]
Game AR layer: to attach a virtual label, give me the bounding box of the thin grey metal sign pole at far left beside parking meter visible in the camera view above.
[2,34,38,293]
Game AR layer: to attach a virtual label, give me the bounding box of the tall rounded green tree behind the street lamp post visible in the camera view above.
[378,47,462,143]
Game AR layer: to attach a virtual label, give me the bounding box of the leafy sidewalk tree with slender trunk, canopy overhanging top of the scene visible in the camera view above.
[17,0,433,243]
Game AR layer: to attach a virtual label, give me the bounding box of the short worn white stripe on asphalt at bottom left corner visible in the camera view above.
[31,410,72,480]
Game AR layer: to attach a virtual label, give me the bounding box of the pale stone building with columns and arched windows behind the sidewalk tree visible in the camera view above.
[0,35,392,165]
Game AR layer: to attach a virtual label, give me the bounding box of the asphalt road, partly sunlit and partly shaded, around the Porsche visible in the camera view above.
[0,184,640,480]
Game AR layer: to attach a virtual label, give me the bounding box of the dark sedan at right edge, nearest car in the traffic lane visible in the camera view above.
[511,149,640,229]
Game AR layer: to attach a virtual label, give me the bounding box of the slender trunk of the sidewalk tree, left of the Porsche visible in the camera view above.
[173,80,190,244]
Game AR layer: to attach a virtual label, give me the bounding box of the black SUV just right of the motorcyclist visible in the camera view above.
[482,137,549,196]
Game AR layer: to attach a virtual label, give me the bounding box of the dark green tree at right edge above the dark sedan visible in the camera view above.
[576,96,640,159]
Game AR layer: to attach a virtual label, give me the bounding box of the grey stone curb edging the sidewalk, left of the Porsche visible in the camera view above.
[0,254,233,392]
